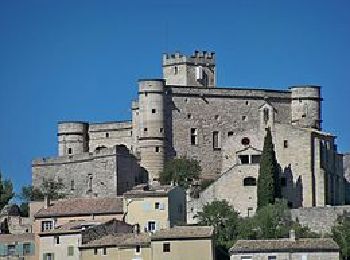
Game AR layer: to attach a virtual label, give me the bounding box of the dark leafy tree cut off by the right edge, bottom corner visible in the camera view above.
[332,217,350,259]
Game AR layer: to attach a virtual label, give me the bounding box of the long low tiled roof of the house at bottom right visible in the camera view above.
[230,238,339,254]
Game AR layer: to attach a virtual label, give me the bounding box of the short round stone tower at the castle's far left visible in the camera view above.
[57,121,89,156]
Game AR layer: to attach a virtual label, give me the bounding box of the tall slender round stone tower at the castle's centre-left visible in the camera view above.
[139,79,165,184]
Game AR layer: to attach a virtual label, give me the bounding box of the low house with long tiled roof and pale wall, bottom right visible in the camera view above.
[230,238,340,260]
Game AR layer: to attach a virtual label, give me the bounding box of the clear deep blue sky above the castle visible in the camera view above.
[0,0,350,193]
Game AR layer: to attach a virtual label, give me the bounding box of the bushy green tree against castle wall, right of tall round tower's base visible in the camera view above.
[159,158,202,188]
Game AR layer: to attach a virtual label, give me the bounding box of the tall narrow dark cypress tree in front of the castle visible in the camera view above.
[257,128,281,208]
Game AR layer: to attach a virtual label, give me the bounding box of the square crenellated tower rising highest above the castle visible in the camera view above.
[163,51,216,88]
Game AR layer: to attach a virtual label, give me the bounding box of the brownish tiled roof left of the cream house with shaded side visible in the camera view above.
[34,197,123,218]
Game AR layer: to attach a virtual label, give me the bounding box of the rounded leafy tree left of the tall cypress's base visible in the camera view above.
[198,200,239,249]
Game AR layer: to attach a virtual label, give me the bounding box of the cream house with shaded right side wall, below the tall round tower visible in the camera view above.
[124,185,186,232]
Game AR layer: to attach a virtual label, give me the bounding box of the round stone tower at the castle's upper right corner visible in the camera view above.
[290,86,322,130]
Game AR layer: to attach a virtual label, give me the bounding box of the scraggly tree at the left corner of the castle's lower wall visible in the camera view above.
[20,180,66,217]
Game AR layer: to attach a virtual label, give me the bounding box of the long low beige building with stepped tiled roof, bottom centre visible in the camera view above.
[80,226,214,260]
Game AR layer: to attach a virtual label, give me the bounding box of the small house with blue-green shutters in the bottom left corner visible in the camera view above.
[0,233,36,260]
